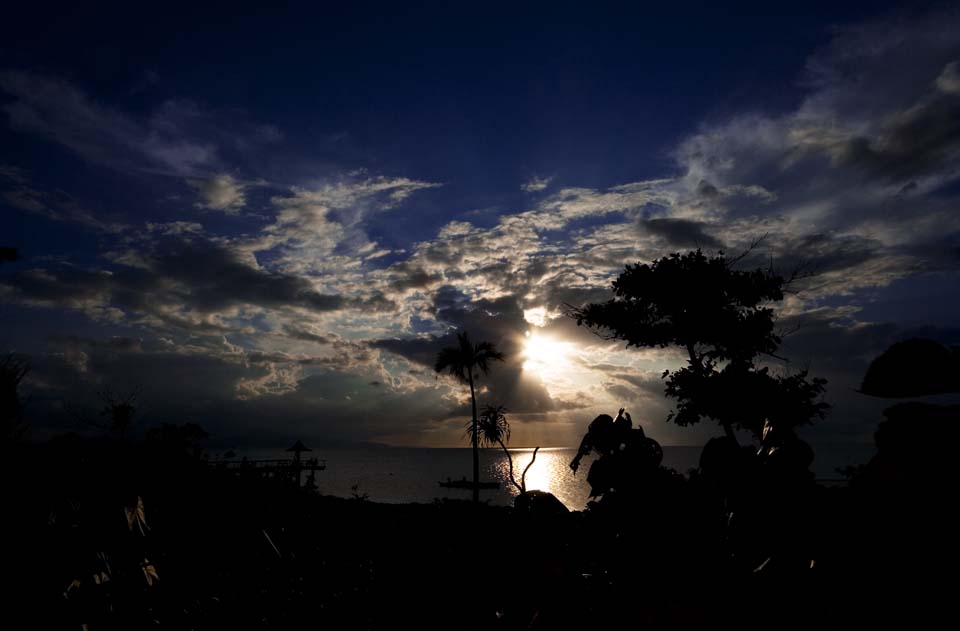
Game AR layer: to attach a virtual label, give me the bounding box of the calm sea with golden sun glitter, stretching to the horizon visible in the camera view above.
[238,444,876,510]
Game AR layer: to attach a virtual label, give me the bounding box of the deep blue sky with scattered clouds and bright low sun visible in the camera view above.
[0,2,960,447]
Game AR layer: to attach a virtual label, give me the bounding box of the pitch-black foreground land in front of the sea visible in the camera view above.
[5,441,949,629]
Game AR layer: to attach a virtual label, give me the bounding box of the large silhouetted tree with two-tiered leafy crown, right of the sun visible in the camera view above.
[568,250,828,441]
